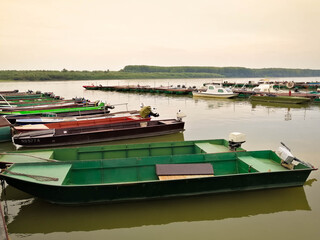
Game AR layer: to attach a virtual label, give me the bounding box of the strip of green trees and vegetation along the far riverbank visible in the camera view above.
[0,65,320,81]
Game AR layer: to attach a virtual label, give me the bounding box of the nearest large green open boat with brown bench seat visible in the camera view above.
[0,151,316,205]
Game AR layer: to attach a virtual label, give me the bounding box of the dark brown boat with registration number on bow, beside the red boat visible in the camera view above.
[12,119,184,147]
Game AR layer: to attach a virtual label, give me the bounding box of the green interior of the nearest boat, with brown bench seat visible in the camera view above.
[2,150,308,186]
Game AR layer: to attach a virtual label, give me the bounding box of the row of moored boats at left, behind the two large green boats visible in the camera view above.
[0,90,184,148]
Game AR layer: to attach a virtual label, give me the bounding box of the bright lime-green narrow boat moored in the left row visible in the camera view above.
[0,103,105,115]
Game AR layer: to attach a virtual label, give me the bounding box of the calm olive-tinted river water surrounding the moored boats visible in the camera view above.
[0,78,320,240]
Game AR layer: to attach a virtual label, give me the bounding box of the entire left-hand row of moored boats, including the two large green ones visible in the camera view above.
[0,89,316,205]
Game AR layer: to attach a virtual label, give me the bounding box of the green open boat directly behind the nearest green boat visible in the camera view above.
[0,139,244,165]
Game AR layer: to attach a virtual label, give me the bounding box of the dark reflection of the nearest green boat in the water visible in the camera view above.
[2,179,314,234]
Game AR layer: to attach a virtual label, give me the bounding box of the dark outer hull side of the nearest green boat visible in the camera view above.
[1,161,311,205]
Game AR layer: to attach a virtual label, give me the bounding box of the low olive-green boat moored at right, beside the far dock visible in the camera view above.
[249,95,310,104]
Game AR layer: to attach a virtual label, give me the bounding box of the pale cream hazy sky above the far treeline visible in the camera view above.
[0,0,320,70]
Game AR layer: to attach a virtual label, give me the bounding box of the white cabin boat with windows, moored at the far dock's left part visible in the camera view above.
[192,85,239,98]
